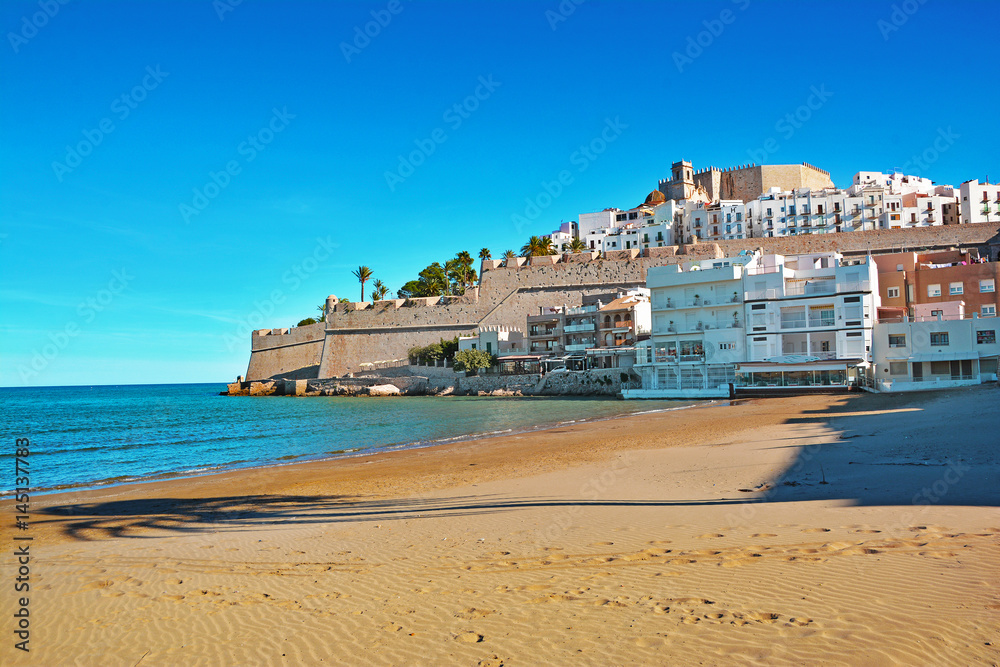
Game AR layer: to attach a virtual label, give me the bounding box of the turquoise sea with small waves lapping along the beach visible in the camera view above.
[0,384,691,492]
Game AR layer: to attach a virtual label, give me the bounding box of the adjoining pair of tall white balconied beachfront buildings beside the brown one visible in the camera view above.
[623,253,879,398]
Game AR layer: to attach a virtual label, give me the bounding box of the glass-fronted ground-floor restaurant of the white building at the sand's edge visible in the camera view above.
[736,354,867,396]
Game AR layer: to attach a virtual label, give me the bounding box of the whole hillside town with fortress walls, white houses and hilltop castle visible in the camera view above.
[238,160,1000,398]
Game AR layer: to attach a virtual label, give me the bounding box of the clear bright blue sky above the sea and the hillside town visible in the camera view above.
[0,0,1000,386]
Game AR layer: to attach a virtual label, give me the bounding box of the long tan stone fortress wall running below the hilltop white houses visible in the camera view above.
[246,223,1000,380]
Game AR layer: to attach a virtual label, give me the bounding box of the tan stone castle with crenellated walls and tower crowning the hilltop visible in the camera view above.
[659,160,834,203]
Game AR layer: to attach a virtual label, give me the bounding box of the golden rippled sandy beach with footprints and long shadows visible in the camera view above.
[0,385,1000,667]
